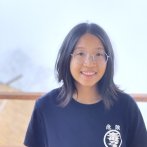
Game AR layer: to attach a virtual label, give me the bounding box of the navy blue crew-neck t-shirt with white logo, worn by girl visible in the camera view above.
[24,89,147,147]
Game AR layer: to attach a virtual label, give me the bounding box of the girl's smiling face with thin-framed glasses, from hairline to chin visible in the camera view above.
[70,33,108,88]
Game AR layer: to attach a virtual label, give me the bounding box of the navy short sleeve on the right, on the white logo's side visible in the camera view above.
[127,99,147,147]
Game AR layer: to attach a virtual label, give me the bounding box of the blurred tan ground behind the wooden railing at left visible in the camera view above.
[0,85,35,147]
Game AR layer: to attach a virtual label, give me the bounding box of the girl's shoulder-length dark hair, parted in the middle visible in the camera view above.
[55,23,120,108]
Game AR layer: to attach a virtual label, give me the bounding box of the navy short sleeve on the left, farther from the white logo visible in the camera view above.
[24,102,45,147]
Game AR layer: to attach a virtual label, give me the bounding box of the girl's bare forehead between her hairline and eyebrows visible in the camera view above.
[75,33,104,50]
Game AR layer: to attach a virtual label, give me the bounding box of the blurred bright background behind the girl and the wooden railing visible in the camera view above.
[0,0,147,145]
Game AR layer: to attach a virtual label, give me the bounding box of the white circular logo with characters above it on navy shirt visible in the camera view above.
[103,124,122,147]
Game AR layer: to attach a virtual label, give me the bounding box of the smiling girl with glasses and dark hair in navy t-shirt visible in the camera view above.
[24,23,147,147]
